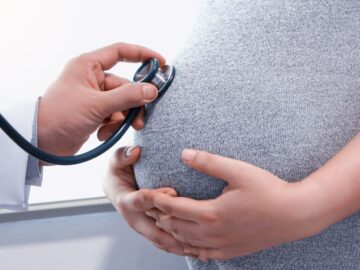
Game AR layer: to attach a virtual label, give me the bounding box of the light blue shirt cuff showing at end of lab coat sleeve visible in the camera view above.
[25,98,43,188]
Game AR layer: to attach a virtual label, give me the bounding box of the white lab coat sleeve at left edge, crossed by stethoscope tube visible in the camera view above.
[0,98,42,210]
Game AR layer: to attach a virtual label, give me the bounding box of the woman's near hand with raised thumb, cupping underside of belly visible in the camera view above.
[145,150,326,260]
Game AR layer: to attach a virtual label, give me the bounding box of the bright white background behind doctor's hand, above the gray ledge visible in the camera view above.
[0,0,198,203]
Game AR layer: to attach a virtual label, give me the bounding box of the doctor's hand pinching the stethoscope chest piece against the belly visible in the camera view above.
[38,43,165,158]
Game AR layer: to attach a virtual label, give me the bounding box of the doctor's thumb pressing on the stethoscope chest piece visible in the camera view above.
[99,83,158,118]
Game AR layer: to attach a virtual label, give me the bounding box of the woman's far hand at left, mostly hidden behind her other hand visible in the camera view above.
[103,147,189,256]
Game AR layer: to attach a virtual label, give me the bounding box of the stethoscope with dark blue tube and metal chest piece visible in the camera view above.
[0,58,175,165]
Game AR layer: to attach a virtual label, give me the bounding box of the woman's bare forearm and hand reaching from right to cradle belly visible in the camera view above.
[106,134,360,260]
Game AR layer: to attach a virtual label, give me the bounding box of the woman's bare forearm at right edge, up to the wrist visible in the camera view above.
[304,133,360,231]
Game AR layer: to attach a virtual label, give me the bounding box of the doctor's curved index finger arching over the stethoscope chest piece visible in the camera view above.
[77,42,165,70]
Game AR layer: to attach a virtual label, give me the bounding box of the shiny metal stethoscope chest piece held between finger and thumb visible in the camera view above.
[133,58,175,97]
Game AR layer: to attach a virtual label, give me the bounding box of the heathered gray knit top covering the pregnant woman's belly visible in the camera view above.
[135,0,360,270]
